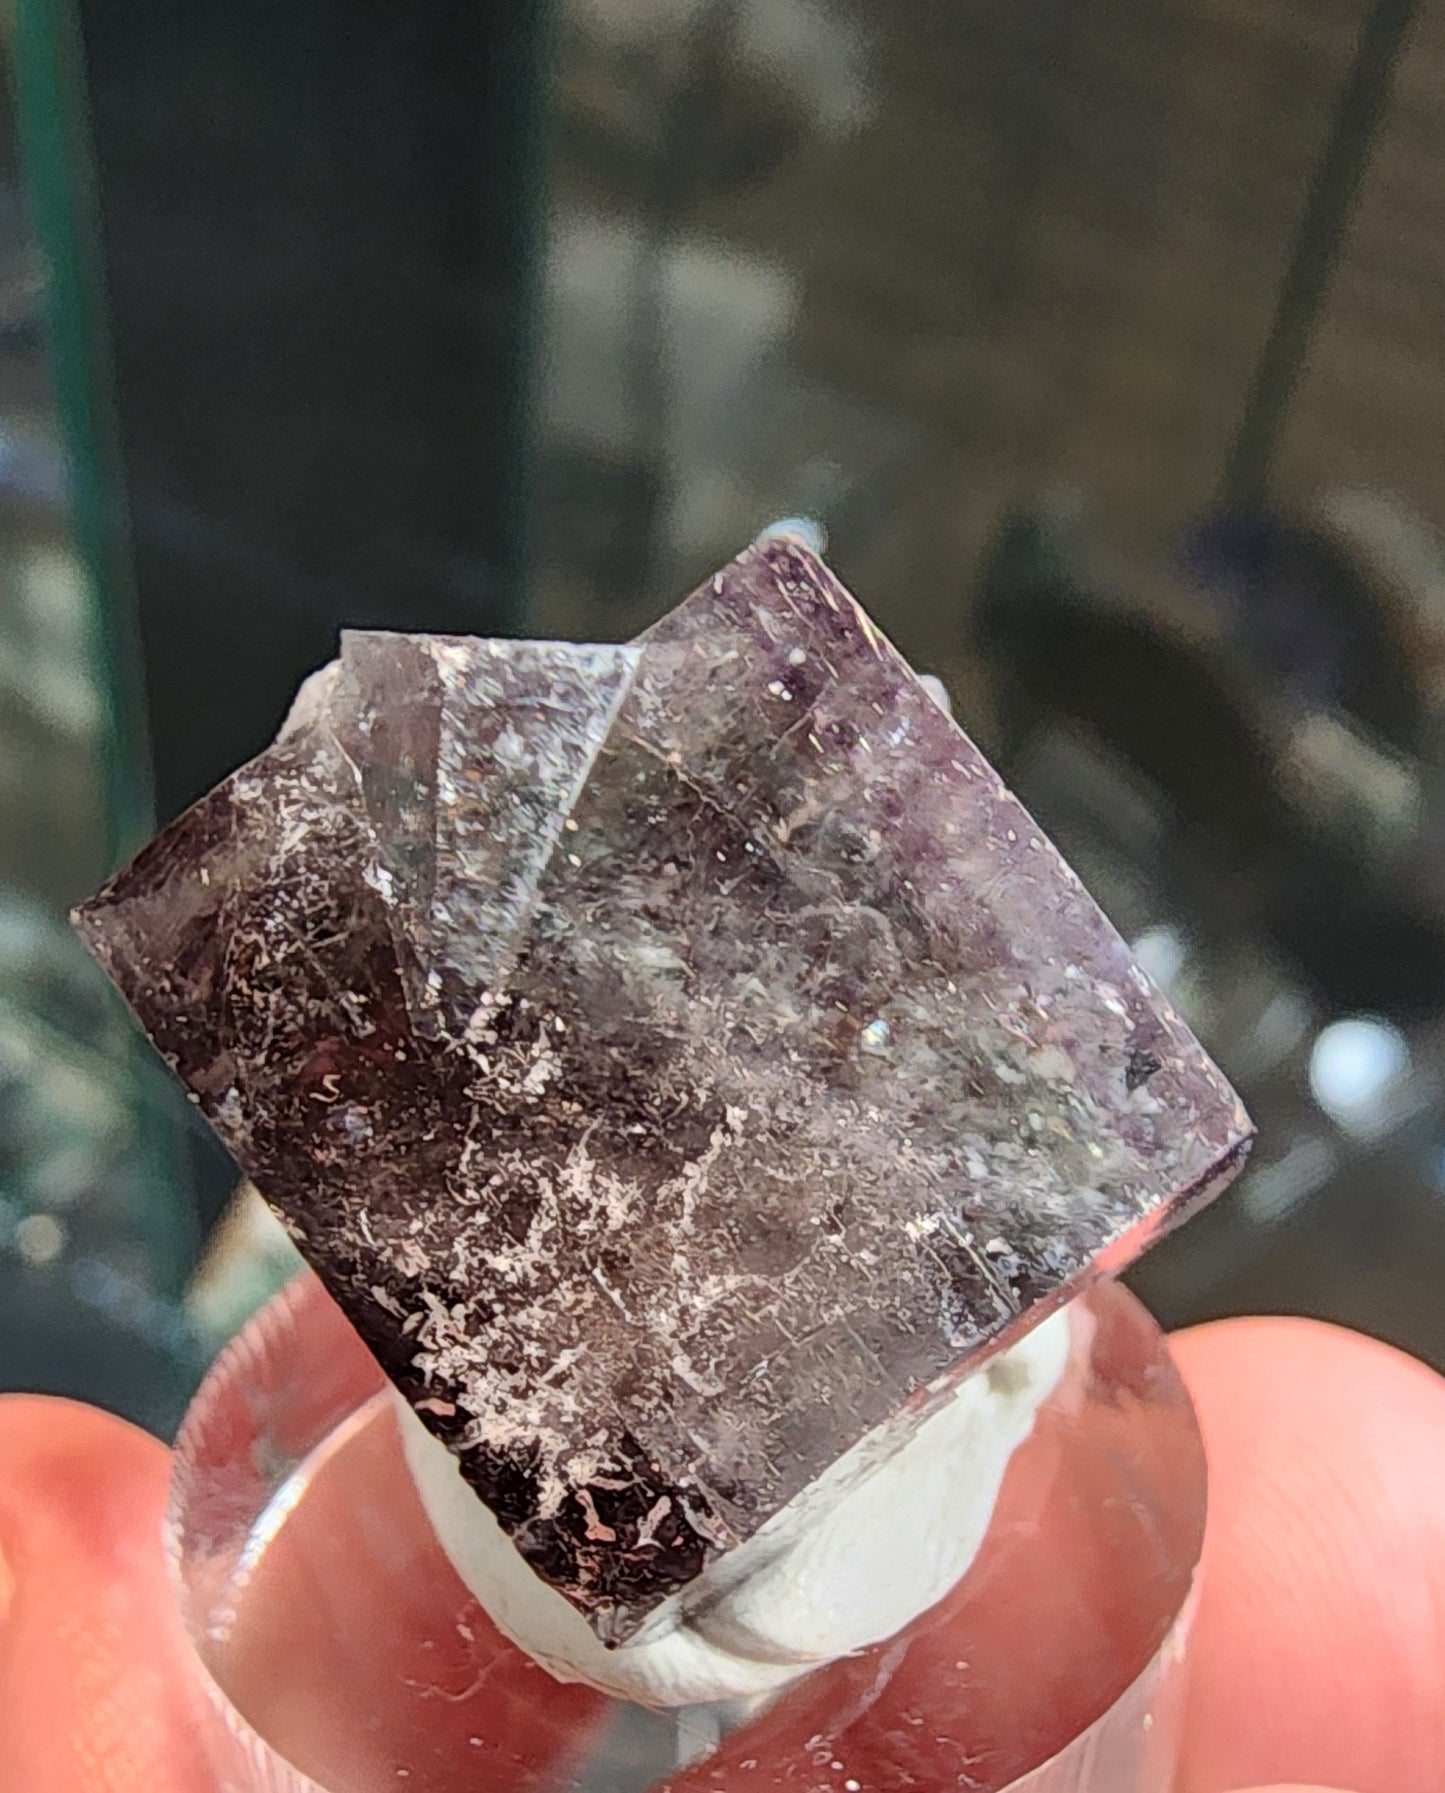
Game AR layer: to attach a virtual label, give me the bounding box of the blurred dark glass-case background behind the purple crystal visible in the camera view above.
[0,0,1445,1431]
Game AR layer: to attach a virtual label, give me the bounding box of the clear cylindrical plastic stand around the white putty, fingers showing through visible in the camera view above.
[169,1277,1205,1793]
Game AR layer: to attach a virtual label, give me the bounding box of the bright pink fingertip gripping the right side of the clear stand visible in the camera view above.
[1174,1320,1445,1793]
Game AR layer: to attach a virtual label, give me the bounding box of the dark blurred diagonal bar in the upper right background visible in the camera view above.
[1223,0,1418,504]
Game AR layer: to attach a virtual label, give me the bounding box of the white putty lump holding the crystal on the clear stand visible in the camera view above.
[398,1311,1069,1705]
